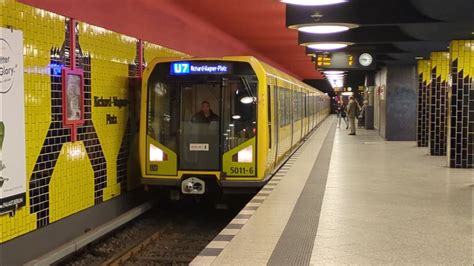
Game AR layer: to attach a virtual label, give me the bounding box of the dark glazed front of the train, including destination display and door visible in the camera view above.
[147,61,258,170]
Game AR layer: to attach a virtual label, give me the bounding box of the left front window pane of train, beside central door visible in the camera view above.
[147,82,179,151]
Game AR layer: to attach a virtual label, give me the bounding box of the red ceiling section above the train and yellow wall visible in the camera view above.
[21,0,322,79]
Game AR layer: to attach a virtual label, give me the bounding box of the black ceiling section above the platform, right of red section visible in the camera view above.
[286,0,474,64]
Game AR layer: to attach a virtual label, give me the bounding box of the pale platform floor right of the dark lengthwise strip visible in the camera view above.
[311,125,474,265]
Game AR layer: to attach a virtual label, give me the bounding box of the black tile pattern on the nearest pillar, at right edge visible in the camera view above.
[448,58,474,168]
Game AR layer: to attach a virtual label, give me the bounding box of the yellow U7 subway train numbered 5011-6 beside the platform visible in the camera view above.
[140,56,330,194]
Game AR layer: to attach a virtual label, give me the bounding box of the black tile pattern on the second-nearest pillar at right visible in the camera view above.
[430,66,448,155]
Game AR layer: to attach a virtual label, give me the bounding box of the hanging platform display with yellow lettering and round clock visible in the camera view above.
[315,51,375,70]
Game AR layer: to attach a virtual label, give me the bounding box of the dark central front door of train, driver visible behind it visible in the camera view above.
[179,82,222,171]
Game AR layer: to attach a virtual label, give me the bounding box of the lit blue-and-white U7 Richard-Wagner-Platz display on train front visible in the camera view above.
[170,62,232,76]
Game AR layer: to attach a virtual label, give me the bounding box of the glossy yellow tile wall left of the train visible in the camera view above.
[0,0,186,243]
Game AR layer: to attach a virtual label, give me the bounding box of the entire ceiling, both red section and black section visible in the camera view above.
[20,0,474,87]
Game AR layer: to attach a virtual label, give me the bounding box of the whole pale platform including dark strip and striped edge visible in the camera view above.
[192,117,474,265]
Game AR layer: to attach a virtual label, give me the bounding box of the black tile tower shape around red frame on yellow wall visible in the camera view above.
[29,20,107,228]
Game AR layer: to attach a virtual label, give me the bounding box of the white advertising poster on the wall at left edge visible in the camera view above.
[0,28,26,214]
